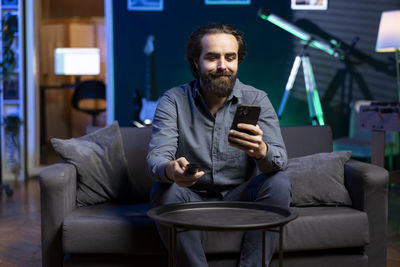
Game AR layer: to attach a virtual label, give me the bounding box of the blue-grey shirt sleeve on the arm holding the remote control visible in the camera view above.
[147,94,178,183]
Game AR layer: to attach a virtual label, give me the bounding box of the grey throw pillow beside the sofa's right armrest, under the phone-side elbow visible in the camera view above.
[285,151,352,206]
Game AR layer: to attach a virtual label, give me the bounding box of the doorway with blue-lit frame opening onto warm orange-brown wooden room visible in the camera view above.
[24,0,114,176]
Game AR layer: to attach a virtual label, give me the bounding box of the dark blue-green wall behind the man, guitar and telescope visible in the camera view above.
[113,0,400,137]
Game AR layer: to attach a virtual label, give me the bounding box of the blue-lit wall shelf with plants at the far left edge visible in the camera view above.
[0,0,25,183]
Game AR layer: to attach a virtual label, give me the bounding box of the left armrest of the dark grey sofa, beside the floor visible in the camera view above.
[39,163,77,267]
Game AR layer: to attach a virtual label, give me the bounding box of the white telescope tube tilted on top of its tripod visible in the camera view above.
[258,7,344,60]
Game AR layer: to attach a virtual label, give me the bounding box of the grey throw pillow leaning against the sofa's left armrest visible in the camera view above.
[50,122,130,206]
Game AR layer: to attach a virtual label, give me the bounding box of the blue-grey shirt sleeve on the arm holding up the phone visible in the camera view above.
[256,95,287,173]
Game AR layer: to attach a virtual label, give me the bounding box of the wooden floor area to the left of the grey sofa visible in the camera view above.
[0,179,42,267]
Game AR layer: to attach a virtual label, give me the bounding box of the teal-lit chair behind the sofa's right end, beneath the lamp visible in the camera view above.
[333,100,400,170]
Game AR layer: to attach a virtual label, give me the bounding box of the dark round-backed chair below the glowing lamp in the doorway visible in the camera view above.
[72,80,107,126]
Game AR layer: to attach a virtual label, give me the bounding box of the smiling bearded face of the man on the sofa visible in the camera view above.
[195,33,239,97]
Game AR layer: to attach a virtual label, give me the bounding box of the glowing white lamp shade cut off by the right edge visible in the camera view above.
[375,10,400,52]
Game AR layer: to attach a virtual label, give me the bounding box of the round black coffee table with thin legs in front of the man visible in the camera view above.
[147,201,297,267]
